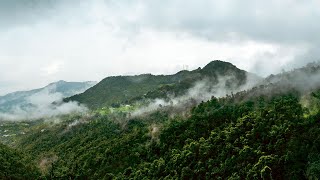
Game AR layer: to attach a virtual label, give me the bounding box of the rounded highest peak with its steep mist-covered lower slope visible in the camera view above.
[133,61,262,101]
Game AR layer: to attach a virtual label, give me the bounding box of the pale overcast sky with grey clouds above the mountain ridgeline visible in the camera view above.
[0,0,320,95]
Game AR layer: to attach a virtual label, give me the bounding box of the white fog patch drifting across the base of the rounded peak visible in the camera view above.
[131,74,260,117]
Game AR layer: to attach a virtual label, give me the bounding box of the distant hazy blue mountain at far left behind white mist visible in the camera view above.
[0,81,96,112]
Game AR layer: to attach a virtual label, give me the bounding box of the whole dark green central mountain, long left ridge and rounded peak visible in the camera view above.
[64,60,261,109]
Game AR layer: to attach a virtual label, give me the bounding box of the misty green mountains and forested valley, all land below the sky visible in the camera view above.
[0,60,320,179]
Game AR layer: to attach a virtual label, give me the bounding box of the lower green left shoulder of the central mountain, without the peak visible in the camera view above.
[65,74,182,108]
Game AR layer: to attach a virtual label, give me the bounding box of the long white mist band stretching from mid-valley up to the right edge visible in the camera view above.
[132,62,320,116]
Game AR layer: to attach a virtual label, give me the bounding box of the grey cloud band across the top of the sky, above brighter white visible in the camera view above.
[0,0,320,43]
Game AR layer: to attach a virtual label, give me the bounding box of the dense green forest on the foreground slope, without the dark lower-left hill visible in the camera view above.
[12,87,320,179]
